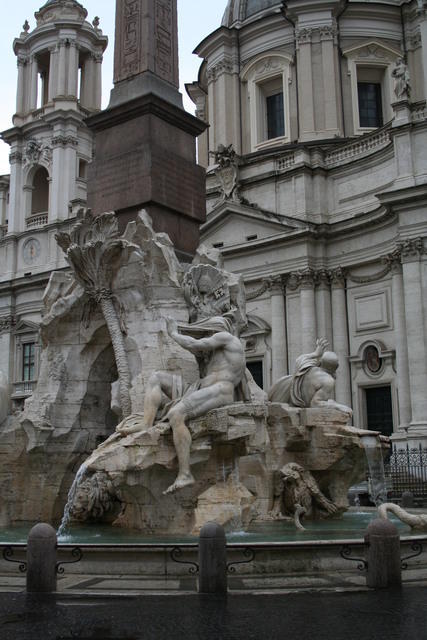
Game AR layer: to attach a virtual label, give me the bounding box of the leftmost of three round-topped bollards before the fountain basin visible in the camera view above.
[27,523,57,593]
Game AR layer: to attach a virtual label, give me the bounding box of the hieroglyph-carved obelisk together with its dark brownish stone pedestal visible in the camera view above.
[86,0,206,259]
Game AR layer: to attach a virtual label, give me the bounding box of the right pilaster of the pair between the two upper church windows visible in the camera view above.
[320,25,340,135]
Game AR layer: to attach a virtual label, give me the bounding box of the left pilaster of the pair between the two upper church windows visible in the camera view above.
[296,28,315,141]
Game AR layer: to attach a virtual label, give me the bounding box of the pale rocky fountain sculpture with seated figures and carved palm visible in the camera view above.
[0,211,382,534]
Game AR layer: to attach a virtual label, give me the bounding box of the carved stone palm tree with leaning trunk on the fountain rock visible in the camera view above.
[55,211,136,418]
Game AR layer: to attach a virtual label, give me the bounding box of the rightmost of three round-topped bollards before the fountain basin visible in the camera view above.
[365,518,402,589]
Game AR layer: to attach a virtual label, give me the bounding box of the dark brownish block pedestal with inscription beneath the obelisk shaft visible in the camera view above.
[86,94,206,255]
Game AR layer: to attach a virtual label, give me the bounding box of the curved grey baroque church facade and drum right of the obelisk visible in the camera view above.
[187,0,427,446]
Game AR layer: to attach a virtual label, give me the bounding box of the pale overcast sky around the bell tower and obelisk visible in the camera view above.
[0,0,227,175]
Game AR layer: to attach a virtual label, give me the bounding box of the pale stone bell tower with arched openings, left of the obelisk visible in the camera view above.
[2,0,108,237]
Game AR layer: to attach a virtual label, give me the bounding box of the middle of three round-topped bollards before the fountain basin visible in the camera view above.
[199,522,227,593]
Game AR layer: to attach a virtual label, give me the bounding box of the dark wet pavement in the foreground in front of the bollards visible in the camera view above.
[0,587,427,640]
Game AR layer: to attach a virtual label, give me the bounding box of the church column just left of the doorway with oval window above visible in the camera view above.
[331,268,352,407]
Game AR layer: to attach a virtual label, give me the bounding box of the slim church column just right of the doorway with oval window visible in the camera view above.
[388,251,411,428]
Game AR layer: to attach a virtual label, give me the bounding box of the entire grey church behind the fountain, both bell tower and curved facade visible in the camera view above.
[0,0,427,446]
